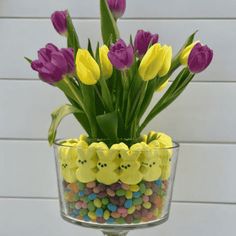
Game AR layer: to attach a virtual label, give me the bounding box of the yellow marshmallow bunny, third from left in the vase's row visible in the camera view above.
[96,142,120,185]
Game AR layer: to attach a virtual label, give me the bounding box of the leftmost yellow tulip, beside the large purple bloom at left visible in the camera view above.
[75,49,100,85]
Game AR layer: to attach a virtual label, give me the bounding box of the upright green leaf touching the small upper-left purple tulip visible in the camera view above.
[67,13,80,56]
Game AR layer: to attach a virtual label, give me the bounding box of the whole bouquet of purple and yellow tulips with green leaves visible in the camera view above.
[26,0,213,144]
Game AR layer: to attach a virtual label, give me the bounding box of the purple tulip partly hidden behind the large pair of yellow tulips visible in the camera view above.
[134,30,159,57]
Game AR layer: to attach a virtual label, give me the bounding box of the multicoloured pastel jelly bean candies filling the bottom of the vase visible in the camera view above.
[63,179,168,224]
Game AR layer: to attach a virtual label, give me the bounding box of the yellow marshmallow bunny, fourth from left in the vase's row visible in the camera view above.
[120,143,143,185]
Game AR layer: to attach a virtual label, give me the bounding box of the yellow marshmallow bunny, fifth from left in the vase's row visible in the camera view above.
[141,140,161,181]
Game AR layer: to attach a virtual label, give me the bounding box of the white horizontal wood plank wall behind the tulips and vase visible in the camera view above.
[0,0,236,236]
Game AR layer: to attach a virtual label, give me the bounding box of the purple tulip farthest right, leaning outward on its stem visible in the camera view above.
[188,43,213,73]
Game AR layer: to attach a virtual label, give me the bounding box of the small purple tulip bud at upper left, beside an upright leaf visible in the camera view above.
[51,11,68,36]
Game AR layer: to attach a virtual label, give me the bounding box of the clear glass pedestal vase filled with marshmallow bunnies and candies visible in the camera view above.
[54,139,179,236]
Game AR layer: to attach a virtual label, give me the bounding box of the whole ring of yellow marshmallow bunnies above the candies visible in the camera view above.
[59,133,172,185]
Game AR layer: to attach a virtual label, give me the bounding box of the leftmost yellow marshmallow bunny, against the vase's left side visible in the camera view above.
[59,139,78,183]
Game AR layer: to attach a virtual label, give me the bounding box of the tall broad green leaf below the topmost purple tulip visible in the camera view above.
[100,0,120,45]
